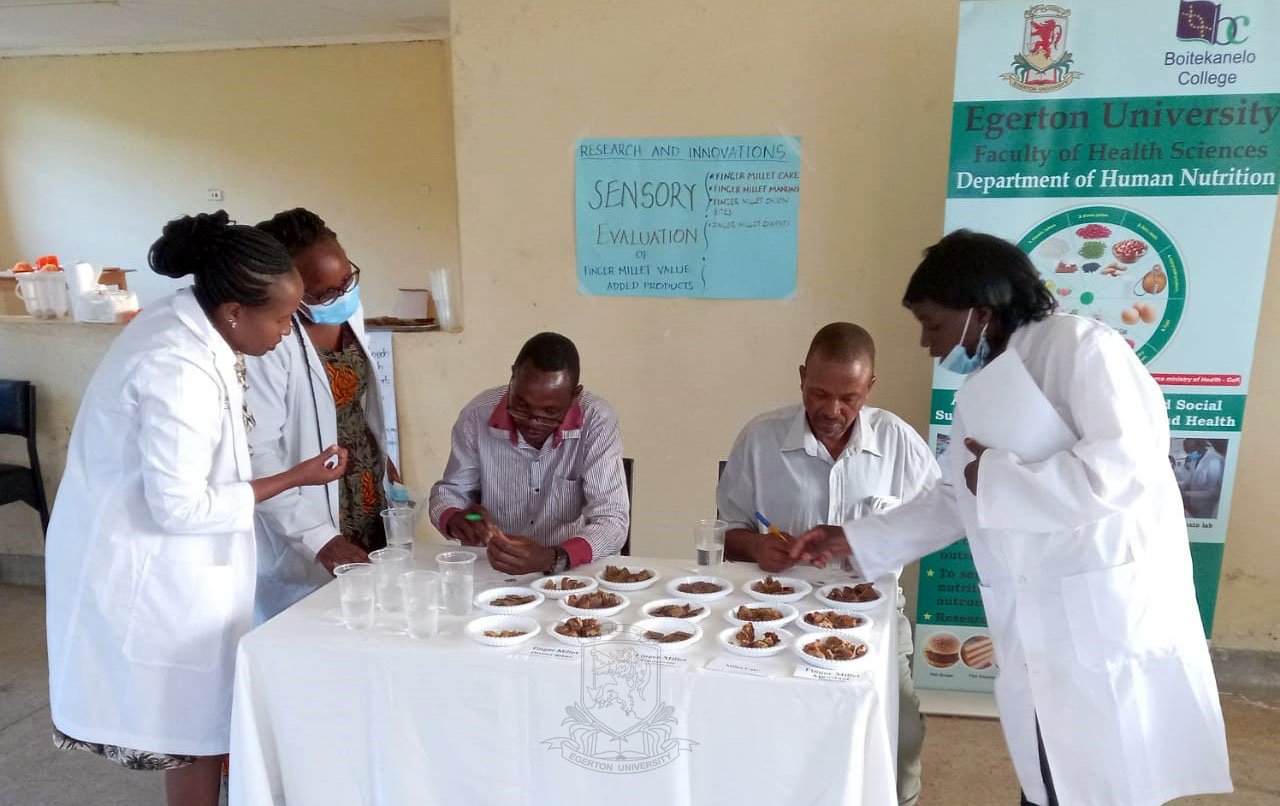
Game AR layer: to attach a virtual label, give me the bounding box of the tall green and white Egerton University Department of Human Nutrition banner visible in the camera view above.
[915,0,1280,691]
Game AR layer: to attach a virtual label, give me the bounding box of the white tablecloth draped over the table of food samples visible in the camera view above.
[230,545,897,806]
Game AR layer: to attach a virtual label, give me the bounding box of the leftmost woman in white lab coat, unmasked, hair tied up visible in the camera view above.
[45,211,346,805]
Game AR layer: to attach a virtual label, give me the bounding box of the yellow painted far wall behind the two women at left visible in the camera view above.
[0,42,457,313]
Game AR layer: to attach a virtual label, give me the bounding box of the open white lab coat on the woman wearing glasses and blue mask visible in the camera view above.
[244,307,387,623]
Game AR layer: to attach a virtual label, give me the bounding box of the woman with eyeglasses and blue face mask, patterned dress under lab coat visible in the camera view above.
[247,207,399,622]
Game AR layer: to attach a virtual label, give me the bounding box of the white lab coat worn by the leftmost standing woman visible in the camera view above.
[45,288,255,756]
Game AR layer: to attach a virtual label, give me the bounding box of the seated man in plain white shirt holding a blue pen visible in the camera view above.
[716,322,940,803]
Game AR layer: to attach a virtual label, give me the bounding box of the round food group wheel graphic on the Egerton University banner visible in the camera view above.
[1018,206,1187,363]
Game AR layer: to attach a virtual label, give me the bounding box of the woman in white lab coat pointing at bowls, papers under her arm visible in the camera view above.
[795,230,1231,806]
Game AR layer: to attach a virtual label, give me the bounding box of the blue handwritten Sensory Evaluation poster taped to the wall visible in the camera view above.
[576,137,800,299]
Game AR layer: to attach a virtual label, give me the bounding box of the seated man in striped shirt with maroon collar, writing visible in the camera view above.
[430,333,630,574]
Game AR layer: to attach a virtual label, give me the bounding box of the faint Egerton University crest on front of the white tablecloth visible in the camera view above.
[543,633,696,773]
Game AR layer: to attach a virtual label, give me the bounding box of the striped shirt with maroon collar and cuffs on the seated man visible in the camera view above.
[430,386,630,565]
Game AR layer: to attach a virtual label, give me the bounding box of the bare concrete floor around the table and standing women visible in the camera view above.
[0,586,1280,806]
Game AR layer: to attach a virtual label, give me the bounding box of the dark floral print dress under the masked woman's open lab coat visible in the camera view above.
[316,328,387,551]
